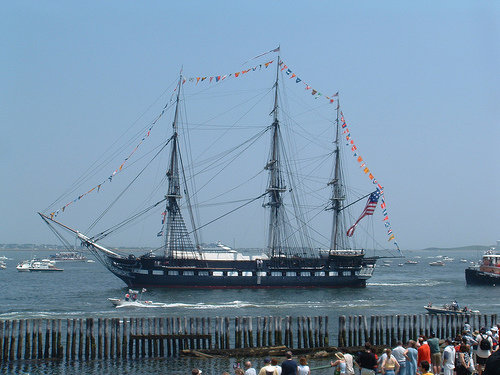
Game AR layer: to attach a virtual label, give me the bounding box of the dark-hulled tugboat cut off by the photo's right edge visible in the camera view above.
[465,240,500,286]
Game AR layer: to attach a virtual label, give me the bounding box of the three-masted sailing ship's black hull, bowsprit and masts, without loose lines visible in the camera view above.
[40,53,386,288]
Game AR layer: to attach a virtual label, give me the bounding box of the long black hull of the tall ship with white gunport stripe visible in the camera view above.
[102,257,376,289]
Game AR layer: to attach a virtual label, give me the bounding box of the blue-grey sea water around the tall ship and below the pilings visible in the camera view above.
[0,250,500,375]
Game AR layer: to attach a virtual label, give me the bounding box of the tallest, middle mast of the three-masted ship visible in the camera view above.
[266,56,286,256]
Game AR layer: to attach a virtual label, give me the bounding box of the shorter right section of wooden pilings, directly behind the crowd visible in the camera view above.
[338,314,497,347]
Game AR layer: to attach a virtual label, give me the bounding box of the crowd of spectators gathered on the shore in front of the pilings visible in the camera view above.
[192,324,500,375]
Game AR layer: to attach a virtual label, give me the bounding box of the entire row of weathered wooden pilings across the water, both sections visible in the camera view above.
[0,314,497,362]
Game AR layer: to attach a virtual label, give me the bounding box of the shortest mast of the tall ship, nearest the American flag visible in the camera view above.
[328,98,345,250]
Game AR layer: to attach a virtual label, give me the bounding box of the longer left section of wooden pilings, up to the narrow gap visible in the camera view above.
[0,316,329,362]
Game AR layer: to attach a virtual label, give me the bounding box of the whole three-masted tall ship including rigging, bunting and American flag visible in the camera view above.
[39,51,400,288]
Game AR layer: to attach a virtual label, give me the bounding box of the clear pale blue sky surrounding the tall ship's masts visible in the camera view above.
[0,1,500,253]
